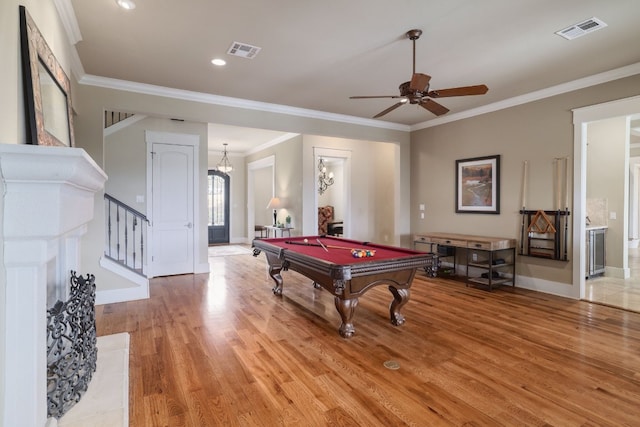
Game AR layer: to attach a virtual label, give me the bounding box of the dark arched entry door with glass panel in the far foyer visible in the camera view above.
[207,170,229,245]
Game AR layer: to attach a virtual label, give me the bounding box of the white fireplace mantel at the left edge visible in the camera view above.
[0,144,107,427]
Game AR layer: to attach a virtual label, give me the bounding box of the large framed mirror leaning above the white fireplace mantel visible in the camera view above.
[20,6,74,147]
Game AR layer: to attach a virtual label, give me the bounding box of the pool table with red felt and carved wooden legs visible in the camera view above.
[252,236,436,338]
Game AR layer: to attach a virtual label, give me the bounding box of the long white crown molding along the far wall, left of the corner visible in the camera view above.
[78,74,410,132]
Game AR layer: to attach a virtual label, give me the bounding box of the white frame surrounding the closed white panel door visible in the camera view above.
[145,130,202,279]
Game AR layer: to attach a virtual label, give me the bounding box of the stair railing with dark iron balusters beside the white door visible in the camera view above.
[104,193,149,277]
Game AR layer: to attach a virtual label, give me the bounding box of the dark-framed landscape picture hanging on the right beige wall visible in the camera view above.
[456,155,500,214]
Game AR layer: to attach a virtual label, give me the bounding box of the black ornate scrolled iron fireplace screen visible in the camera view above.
[47,271,98,418]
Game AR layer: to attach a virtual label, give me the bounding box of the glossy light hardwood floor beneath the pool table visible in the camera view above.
[96,255,640,427]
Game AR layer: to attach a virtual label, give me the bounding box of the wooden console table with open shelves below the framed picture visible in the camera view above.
[413,232,517,290]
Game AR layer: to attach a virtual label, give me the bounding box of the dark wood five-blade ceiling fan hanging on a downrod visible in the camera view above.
[349,30,489,119]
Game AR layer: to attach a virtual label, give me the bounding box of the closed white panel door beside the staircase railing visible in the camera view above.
[151,143,194,276]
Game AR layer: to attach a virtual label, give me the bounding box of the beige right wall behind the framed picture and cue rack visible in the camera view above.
[411,76,640,290]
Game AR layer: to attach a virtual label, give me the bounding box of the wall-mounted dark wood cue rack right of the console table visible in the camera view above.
[519,209,570,261]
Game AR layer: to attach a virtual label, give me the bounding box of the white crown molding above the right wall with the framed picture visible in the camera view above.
[411,62,640,132]
